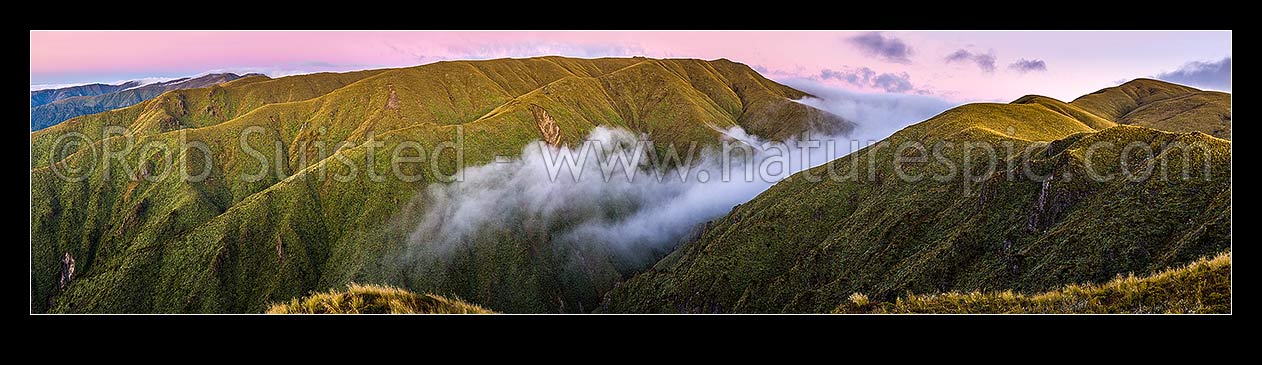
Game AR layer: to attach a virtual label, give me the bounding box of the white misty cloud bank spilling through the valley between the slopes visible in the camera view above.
[408,80,952,269]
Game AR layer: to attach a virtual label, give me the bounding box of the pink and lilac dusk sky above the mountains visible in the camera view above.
[30,32,1232,102]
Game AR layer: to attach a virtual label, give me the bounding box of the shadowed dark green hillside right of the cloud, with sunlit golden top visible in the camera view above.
[602,86,1230,312]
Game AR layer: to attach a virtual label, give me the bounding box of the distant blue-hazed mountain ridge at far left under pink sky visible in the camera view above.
[30,73,250,131]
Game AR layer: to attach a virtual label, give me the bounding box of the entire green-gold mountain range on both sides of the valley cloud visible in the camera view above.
[30,57,1230,313]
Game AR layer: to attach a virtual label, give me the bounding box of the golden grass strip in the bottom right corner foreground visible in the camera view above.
[833,251,1232,313]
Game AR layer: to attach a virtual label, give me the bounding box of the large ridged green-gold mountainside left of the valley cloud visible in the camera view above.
[32,57,851,312]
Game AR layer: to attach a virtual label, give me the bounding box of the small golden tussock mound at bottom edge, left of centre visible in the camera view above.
[268,284,495,314]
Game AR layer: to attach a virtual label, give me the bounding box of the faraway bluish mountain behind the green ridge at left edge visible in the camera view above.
[30,73,254,131]
